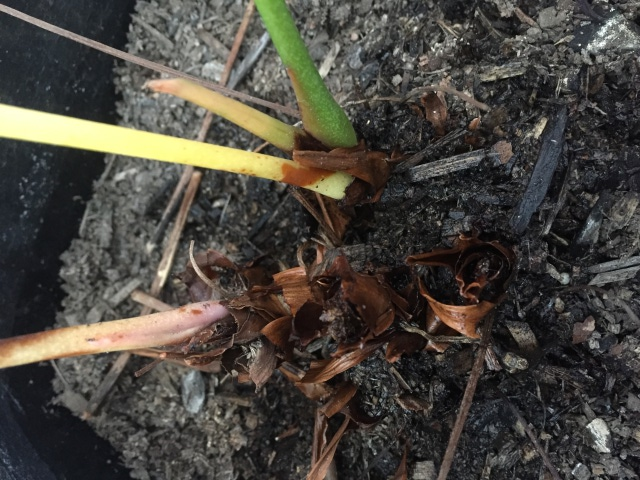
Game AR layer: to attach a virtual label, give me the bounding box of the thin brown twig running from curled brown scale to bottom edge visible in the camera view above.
[437,314,494,480]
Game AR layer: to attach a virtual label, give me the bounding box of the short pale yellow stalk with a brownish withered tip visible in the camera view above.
[145,78,306,152]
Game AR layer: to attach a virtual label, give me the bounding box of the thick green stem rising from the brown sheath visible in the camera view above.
[255,0,358,148]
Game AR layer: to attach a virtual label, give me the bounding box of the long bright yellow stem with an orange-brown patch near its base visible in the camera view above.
[0,104,353,199]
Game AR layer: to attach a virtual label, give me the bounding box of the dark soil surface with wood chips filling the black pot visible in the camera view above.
[56,0,640,480]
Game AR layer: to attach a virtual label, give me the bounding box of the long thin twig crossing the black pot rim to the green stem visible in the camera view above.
[0,4,300,118]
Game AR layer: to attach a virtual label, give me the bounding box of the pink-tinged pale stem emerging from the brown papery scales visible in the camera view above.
[0,302,229,368]
